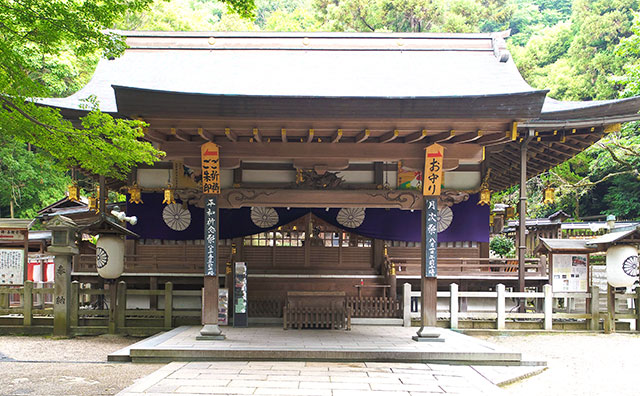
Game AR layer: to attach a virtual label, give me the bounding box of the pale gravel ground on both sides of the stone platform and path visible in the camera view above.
[0,333,640,396]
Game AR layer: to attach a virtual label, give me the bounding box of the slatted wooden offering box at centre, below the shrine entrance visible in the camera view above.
[282,291,351,330]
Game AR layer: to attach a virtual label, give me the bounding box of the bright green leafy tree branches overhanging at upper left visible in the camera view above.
[0,0,255,178]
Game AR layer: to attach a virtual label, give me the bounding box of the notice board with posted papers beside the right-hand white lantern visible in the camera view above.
[552,254,589,292]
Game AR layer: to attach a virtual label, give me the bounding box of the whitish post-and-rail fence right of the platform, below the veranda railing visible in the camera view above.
[403,283,640,332]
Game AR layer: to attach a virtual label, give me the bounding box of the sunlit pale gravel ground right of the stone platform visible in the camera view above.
[478,333,640,396]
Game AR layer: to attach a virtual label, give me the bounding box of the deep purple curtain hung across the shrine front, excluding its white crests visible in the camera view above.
[127,193,489,242]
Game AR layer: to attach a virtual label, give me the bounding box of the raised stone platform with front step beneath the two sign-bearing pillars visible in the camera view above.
[114,326,528,365]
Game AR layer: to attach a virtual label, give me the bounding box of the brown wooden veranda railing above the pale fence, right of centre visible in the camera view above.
[389,257,548,278]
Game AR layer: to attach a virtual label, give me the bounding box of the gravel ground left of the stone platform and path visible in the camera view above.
[0,336,163,396]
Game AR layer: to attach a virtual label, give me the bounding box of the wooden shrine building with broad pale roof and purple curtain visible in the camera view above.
[43,32,640,328]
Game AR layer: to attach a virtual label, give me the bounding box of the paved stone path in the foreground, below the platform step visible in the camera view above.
[117,361,544,396]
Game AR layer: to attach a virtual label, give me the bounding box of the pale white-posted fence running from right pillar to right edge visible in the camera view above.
[403,283,640,330]
